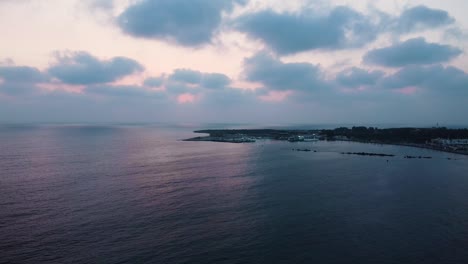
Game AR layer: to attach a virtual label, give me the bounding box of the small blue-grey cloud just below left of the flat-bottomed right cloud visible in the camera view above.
[336,67,384,88]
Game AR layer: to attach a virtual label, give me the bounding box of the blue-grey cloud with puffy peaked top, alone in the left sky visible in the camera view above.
[48,51,144,85]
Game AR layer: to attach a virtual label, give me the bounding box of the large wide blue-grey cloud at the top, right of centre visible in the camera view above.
[235,6,378,55]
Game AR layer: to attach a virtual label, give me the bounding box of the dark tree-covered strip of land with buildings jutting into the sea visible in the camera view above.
[186,126,468,155]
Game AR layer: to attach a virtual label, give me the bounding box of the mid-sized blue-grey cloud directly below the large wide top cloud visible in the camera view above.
[244,52,328,91]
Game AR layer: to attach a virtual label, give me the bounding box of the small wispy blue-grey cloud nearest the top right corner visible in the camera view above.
[394,5,455,33]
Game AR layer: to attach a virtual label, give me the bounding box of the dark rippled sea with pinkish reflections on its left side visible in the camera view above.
[0,125,468,264]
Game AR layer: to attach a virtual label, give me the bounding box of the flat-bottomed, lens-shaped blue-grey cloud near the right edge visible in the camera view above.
[364,38,462,67]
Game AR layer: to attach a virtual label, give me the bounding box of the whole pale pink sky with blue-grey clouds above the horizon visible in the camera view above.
[0,0,468,126]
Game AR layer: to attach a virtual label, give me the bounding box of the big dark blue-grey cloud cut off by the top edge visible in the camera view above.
[117,0,245,46]
